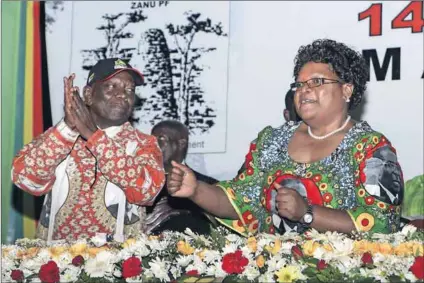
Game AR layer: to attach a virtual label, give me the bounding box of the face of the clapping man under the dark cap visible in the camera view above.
[88,71,135,126]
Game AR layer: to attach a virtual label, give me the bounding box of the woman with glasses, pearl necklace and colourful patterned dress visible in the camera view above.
[168,39,403,235]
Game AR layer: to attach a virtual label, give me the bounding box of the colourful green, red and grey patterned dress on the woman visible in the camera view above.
[218,121,404,236]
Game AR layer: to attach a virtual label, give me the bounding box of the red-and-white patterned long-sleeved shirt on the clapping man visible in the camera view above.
[12,121,165,241]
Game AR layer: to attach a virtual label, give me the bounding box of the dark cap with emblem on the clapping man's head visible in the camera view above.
[87,58,144,86]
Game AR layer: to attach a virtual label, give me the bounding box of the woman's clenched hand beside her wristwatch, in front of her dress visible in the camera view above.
[275,184,308,222]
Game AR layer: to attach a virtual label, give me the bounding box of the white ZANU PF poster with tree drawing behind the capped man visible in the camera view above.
[47,1,229,153]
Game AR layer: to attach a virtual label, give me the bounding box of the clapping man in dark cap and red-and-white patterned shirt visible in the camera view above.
[12,58,165,241]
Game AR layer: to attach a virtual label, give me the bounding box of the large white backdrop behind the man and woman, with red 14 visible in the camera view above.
[47,1,423,183]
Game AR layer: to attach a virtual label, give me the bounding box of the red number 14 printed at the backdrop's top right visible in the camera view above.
[358,1,424,36]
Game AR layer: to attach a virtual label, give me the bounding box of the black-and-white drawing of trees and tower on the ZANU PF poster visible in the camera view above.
[81,9,227,134]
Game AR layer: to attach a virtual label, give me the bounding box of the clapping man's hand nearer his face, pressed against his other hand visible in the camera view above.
[71,87,97,140]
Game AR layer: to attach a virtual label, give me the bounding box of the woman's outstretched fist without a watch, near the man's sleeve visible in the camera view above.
[167,161,198,198]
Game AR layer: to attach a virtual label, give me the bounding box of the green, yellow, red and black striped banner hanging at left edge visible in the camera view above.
[1,1,51,243]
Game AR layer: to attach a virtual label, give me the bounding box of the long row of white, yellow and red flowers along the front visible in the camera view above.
[1,225,424,283]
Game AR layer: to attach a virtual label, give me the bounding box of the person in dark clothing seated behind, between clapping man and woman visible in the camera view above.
[146,120,218,234]
